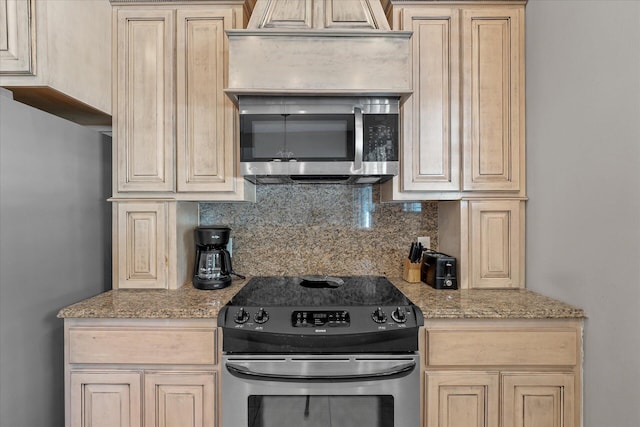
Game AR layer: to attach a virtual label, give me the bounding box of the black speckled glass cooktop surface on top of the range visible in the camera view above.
[227,276,411,307]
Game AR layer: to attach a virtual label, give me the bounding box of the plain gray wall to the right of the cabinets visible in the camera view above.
[526,0,640,427]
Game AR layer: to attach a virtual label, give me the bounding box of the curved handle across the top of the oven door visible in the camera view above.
[226,362,416,382]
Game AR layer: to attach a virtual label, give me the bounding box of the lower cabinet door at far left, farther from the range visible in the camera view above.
[70,372,142,427]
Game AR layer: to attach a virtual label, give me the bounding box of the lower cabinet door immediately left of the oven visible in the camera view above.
[144,372,216,427]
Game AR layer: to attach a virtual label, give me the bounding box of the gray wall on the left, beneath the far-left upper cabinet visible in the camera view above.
[0,90,111,427]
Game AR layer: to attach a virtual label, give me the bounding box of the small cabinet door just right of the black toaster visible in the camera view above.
[462,200,524,288]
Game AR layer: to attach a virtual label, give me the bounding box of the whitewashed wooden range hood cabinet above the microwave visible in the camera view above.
[226,0,412,102]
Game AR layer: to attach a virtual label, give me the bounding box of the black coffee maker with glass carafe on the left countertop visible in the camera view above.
[193,225,242,290]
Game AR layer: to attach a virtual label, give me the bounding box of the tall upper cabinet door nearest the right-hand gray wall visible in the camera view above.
[462,7,524,191]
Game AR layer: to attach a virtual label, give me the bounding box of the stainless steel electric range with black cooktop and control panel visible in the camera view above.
[218,276,423,427]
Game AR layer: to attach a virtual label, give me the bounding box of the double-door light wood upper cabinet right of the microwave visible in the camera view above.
[383,0,526,200]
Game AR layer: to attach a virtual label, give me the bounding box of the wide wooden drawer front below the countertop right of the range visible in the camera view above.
[427,329,579,366]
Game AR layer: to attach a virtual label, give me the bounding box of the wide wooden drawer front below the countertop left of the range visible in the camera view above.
[69,327,217,365]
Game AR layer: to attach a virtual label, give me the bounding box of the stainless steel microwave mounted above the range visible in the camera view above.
[238,96,399,184]
